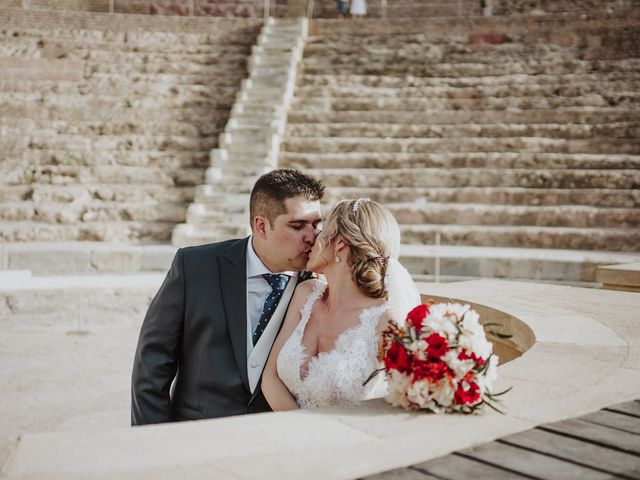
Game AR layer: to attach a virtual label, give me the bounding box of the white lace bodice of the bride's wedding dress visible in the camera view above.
[277,281,388,408]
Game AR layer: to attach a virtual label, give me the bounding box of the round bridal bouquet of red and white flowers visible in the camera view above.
[382,303,506,413]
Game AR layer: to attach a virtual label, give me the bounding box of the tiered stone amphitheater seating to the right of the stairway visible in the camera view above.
[280,13,640,252]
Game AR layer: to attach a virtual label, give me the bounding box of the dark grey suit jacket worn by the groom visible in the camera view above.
[131,238,300,425]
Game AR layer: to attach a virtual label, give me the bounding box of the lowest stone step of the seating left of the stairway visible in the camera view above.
[0,221,175,243]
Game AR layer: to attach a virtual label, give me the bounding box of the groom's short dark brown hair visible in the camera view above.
[249,168,325,228]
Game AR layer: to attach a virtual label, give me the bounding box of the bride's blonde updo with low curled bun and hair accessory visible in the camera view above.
[320,198,400,299]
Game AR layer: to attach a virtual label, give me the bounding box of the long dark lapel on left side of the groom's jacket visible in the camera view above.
[220,238,249,389]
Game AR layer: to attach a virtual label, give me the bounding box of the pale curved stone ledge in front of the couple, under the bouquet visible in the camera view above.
[3,280,640,479]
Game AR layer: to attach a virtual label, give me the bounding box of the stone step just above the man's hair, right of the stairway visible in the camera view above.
[278,152,640,170]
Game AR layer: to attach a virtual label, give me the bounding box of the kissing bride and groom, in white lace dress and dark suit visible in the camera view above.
[131,169,420,425]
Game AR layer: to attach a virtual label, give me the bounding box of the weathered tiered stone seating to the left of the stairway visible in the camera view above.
[0,10,261,243]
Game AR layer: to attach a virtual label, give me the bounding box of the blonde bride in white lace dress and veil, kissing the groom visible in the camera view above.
[262,198,420,410]
